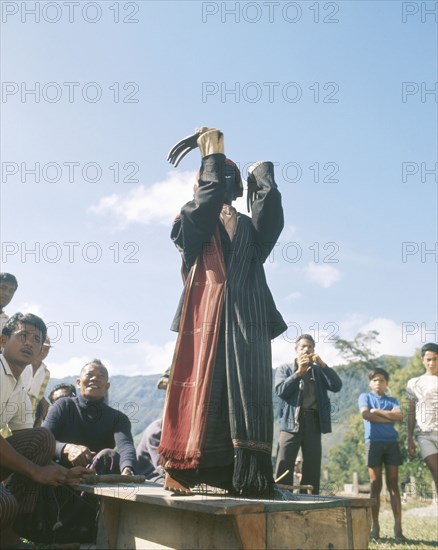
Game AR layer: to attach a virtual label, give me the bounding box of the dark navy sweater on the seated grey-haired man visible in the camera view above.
[43,396,136,471]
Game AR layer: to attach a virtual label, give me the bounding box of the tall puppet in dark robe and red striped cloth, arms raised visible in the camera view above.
[159,128,287,494]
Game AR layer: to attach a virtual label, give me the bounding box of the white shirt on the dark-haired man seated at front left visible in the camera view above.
[0,354,33,431]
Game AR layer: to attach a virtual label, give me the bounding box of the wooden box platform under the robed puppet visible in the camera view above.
[80,482,371,550]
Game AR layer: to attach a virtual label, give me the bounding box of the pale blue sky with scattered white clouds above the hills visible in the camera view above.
[1,1,438,377]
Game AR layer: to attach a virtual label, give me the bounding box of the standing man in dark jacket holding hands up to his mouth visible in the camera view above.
[275,334,342,495]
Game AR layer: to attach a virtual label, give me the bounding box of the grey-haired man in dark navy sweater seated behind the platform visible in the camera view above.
[43,359,136,475]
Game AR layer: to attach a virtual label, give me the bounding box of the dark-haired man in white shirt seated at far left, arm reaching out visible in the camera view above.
[0,313,88,548]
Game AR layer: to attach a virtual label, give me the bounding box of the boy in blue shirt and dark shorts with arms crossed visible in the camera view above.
[359,368,405,542]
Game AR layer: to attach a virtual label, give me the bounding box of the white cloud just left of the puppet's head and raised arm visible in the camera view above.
[89,171,196,228]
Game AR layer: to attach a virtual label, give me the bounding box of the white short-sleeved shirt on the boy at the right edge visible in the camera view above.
[406,373,438,433]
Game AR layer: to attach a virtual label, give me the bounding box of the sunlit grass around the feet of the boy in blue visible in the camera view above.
[369,499,438,550]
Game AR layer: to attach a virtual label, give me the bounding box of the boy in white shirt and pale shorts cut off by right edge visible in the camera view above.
[406,343,438,498]
